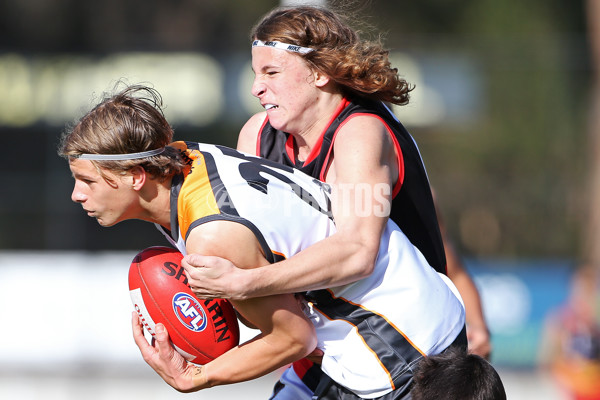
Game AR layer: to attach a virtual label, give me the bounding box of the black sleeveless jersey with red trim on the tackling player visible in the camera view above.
[256,97,446,273]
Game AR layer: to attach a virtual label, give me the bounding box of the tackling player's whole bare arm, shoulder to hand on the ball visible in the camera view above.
[183,116,398,299]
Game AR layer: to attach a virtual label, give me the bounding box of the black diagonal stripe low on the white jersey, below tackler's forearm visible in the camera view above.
[306,290,422,388]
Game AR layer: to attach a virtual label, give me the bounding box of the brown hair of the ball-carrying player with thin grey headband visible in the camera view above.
[58,85,186,178]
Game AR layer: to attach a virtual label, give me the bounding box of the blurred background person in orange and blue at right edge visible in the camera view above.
[540,265,600,400]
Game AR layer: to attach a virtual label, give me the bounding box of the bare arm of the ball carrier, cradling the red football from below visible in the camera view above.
[134,221,316,392]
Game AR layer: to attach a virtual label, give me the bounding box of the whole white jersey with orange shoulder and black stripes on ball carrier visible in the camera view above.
[155,142,465,398]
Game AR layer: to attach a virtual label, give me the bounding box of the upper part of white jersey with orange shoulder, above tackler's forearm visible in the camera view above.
[160,142,335,262]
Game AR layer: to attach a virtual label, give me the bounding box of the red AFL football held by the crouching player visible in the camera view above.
[129,246,240,364]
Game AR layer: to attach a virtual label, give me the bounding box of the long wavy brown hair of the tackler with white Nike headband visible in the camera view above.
[251,6,413,105]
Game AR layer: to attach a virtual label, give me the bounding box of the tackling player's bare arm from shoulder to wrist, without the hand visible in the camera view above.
[252,117,397,293]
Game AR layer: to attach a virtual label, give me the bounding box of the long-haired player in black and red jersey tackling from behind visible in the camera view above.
[183,6,490,399]
